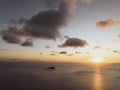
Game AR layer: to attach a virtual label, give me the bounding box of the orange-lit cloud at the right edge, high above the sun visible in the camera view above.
[96,19,120,29]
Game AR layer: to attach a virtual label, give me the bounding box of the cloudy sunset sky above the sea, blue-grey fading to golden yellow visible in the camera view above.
[0,0,120,62]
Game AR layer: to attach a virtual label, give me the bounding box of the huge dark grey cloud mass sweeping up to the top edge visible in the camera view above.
[1,0,77,45]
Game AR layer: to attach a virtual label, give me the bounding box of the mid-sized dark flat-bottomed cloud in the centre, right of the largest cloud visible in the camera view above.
[58,38,88,48]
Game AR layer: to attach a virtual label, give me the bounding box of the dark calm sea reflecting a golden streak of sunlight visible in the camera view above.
[0,61,120,90]
